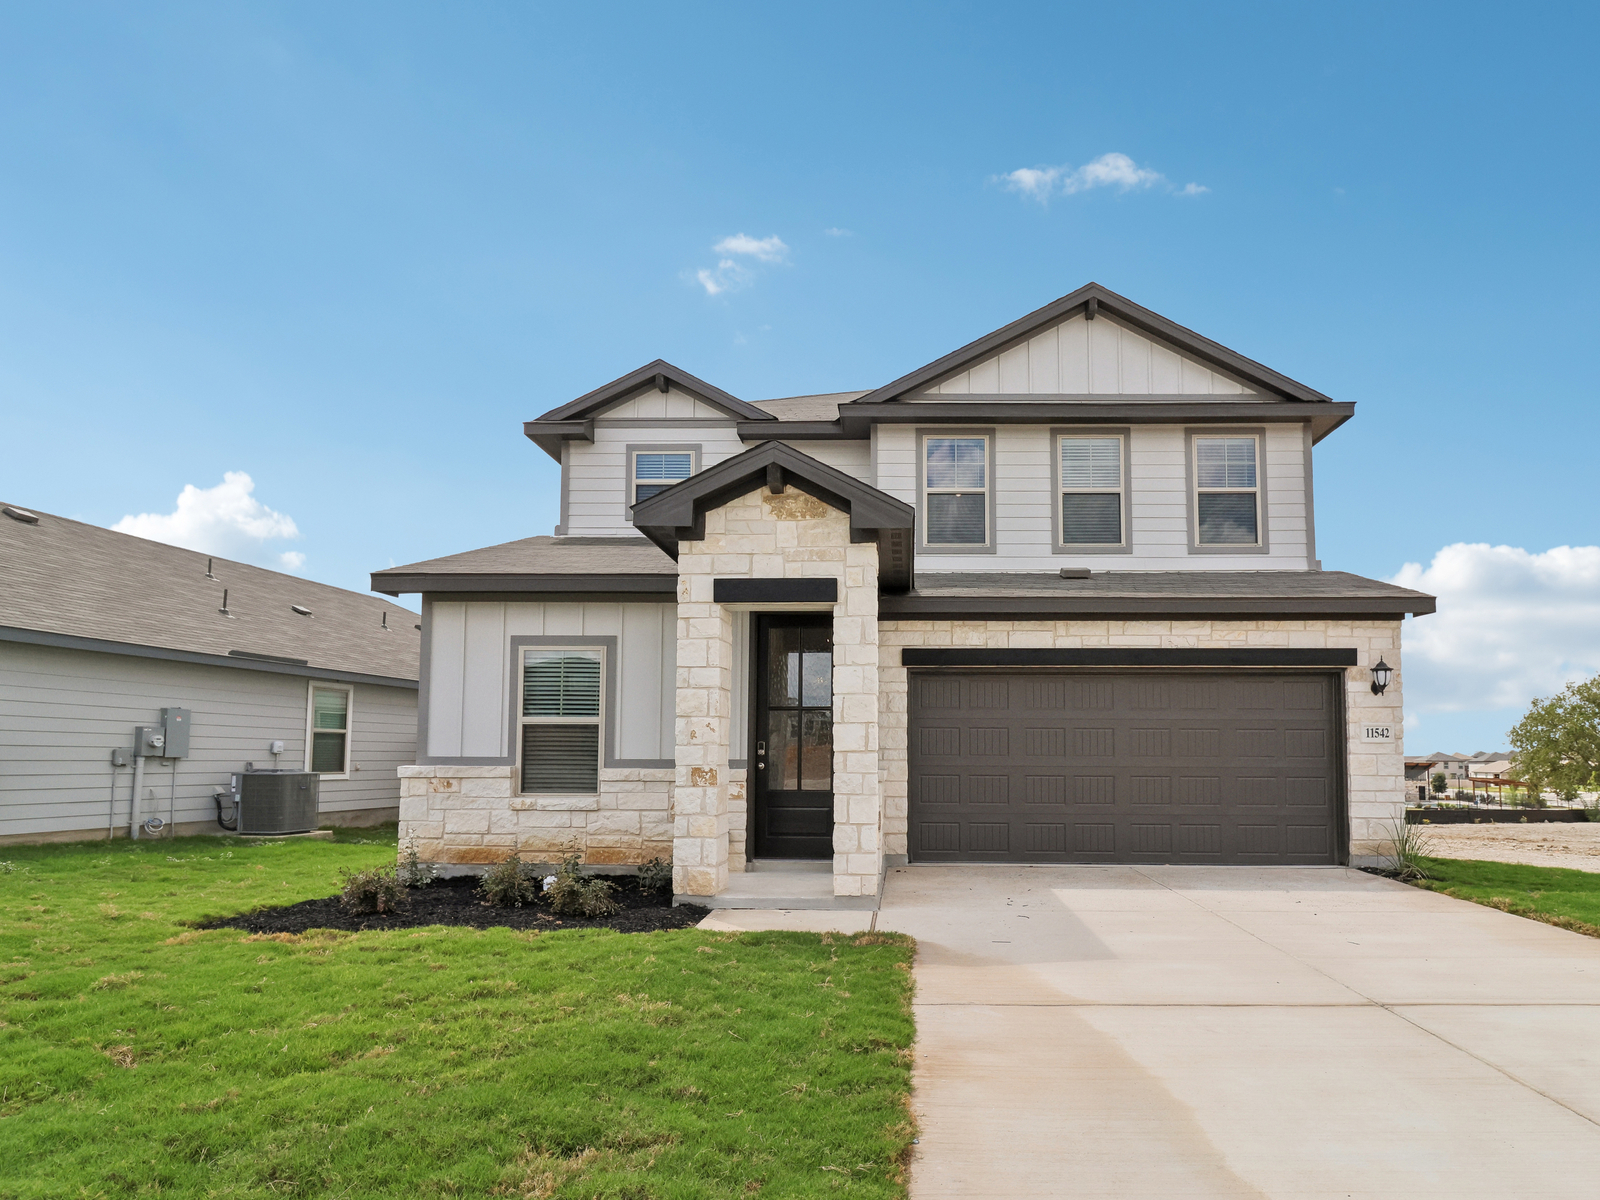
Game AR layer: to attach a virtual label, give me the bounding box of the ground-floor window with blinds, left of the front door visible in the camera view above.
[520,646,605,795]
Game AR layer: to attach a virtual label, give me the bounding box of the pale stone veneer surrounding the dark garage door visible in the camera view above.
[878,621,1405,866]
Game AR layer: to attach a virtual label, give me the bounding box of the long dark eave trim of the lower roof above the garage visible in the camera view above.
[878,592,1438,621]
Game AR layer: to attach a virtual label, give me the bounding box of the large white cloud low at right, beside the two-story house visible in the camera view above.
[1390,542,1600,714]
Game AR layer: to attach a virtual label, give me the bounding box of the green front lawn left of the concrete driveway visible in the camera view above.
[0,829,912,1200]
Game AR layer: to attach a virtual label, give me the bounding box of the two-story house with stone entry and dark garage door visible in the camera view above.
[373,283,1434,904]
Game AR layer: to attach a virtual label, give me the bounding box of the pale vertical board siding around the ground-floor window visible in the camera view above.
[418,600,678,766]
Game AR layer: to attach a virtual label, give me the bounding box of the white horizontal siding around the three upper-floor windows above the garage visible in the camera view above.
[877,424,1310,571]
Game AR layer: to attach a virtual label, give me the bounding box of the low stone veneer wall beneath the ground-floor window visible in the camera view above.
[400,766,672,866]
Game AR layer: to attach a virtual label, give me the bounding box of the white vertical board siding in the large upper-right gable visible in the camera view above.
[925,314,1253,397]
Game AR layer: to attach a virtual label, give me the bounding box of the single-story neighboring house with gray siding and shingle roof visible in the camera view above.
[0,506,421,842]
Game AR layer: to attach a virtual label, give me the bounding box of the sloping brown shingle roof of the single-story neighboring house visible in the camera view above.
[0,509,421,686]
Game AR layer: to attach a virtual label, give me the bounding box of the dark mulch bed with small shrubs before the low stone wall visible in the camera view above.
[202,875,710,933]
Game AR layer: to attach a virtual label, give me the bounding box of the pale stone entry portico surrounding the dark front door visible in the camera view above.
[674,486,883,896]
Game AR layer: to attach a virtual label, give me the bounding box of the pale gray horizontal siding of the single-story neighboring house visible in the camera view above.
[0,643,416,842]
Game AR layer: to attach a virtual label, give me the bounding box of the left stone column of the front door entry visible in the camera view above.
[672,569,733,896]
